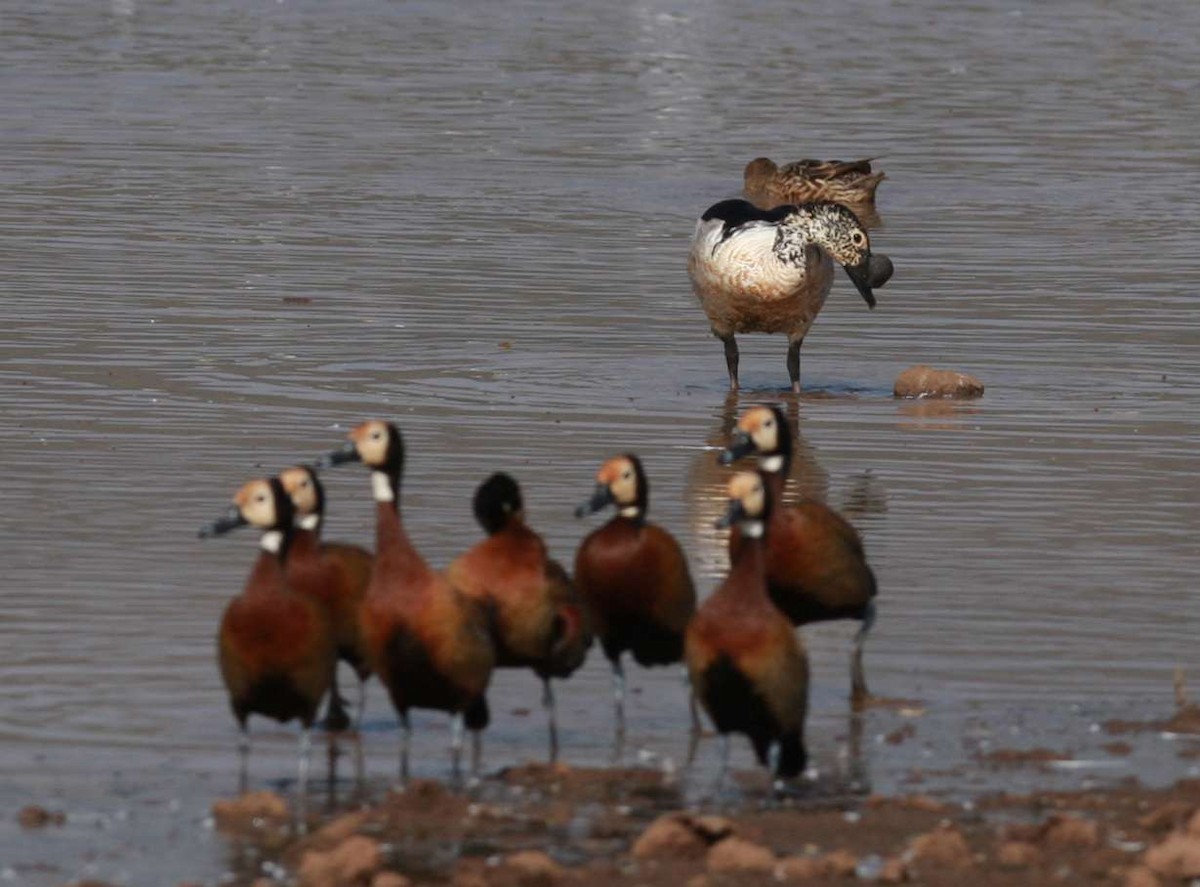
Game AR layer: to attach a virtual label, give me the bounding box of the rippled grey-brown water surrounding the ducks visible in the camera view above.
[0,0,1200,885]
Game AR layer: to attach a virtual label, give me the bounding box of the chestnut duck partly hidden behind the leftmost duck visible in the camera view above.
[278,465,374,731]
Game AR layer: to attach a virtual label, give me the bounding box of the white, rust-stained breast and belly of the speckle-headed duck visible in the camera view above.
[688,220,833,336]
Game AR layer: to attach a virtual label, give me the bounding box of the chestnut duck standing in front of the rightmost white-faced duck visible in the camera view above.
[685,472,809,779]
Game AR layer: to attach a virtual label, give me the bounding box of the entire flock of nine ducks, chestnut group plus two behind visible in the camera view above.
[200,157,892,791]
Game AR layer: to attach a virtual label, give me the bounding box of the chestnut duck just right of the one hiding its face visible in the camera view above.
[574,453,696,735]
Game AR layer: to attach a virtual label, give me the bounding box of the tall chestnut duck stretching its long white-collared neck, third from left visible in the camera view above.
[318,419,496,784]
